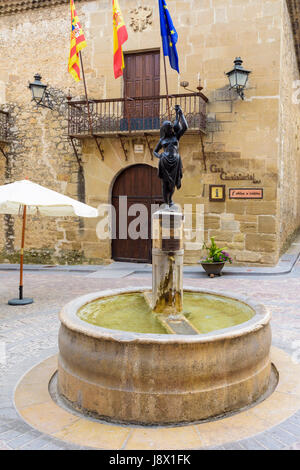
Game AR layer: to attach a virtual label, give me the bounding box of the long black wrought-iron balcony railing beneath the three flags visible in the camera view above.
[68,93,208,138]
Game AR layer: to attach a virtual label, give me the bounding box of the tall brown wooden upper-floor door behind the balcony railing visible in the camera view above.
[124,51,160,130]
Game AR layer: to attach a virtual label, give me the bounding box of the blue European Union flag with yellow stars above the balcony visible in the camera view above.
[158,0,179,73]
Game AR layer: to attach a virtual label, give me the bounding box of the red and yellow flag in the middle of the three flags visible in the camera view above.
[112,0,128,78]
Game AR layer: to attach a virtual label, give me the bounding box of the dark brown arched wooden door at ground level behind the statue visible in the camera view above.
[112,164,163,263]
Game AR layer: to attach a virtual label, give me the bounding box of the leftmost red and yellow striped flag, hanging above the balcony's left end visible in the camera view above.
[68,0,86,82]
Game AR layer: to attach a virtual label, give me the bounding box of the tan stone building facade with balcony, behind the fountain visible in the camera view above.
[0,0,300,265]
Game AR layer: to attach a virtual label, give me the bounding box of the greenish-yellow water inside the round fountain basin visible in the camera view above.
[77,292,255,334]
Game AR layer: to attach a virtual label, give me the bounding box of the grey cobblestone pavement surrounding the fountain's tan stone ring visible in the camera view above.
[0,263,300,450]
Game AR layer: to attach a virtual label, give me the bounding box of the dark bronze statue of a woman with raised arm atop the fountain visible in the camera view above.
[153,105,188,207]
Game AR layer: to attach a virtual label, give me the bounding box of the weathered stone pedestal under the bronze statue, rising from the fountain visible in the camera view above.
[152,206,184,315]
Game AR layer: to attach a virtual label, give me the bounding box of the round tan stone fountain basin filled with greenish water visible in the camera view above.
[58,288,271,424]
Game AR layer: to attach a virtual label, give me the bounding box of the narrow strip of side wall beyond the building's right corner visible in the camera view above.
[278,3,300,251]
